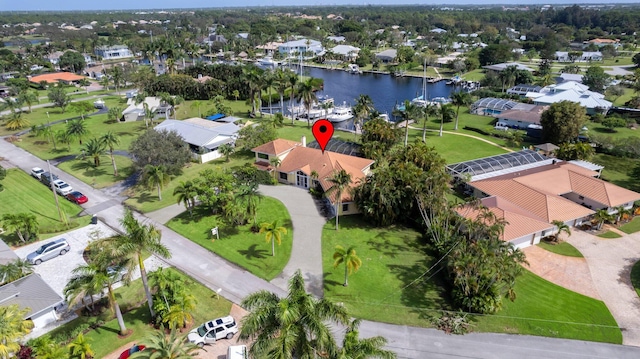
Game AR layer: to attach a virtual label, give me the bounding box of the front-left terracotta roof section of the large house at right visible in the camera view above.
[456,196,553,241]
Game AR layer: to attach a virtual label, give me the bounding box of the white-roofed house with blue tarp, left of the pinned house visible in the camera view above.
[154,117,240,163]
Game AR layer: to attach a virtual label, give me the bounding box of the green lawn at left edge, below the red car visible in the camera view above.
[0,169,82,244]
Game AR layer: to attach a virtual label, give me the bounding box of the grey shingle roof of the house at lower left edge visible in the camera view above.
[0,273,62,319]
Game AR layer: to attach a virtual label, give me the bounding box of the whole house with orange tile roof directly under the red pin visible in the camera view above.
[252,137,374,215]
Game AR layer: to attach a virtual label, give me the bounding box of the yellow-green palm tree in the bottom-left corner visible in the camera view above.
[0,304,33,358]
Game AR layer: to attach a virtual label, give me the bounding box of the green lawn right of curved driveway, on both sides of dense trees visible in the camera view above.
[322,216,622,343]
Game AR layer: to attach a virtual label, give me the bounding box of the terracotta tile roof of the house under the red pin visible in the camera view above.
[276,145,374,202]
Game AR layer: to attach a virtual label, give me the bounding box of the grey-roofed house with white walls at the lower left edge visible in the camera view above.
[0,240,63,328]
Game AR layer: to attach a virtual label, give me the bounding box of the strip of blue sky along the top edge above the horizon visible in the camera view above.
[5,0,637,11]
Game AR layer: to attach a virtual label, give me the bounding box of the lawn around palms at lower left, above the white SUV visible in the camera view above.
[50,269,231,358]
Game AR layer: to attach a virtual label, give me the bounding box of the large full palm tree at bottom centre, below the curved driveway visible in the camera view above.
[240,270,349,358]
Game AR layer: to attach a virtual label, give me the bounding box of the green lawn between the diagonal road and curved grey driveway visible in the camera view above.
[167,197,293,280]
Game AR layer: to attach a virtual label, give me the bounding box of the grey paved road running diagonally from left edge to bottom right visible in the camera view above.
[0,139,640,359]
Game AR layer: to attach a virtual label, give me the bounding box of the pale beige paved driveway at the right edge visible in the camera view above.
[566,229,640,346]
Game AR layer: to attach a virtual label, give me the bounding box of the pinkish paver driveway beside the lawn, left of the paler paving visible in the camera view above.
[522,246,601,300]
